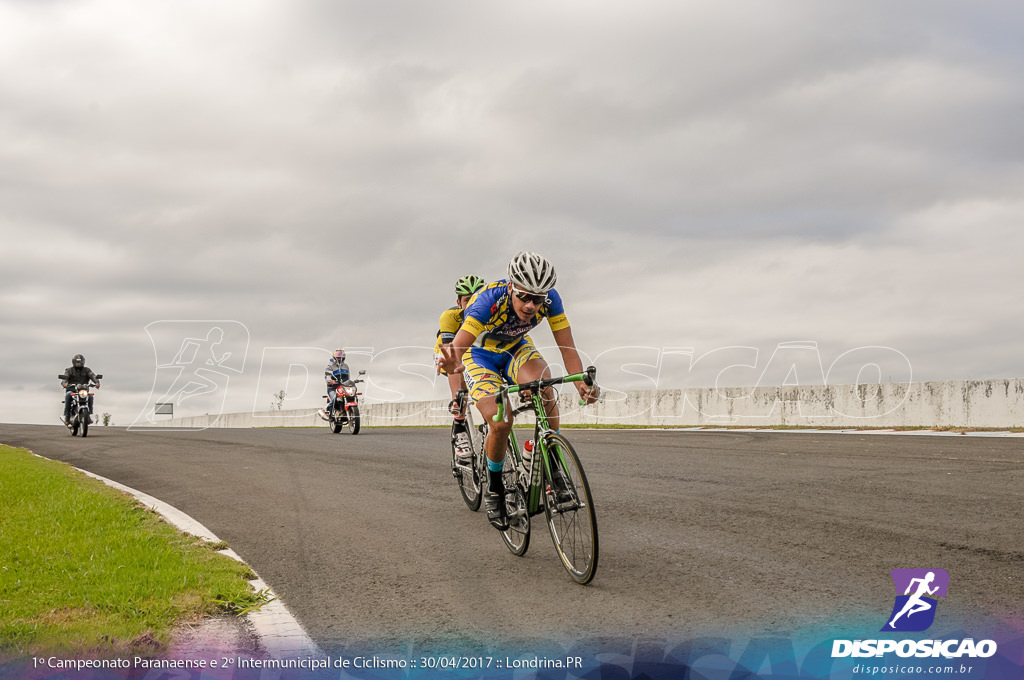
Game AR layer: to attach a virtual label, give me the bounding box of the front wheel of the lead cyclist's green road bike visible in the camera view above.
[544,433,598,585]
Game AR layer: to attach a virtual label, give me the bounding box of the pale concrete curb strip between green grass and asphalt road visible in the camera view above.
[76,468,325,658]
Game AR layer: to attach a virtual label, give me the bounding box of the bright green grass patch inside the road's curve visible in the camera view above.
[0,445,266,658]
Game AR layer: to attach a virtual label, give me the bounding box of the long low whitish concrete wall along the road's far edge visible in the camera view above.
[146,378,1024,428]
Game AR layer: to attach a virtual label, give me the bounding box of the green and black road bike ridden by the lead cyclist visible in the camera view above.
[494,367,598,585]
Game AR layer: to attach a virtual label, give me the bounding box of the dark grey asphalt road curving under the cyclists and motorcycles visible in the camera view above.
[0,425,1024,649]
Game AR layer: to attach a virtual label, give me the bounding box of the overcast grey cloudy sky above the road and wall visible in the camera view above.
[0,0,1024,425]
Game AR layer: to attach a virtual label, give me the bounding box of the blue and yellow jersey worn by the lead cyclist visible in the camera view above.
[462,280,569,352]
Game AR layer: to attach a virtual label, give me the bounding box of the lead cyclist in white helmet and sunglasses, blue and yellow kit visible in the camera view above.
[438,252,598,530]
